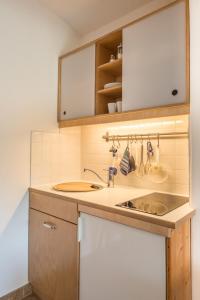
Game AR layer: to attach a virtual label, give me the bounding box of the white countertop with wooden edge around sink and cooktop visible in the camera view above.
[30,184,195,228]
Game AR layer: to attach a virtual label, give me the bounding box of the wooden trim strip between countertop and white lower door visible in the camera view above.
[78,204,173,238]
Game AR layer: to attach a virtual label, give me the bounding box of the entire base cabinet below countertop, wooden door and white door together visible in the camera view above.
[29,192,192,300]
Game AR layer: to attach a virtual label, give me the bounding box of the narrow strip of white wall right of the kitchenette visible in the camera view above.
[190,0,200,300]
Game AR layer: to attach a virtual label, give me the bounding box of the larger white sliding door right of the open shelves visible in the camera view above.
[123,2,186,111]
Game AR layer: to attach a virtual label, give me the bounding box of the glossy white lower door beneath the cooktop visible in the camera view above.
[79,214,166,300]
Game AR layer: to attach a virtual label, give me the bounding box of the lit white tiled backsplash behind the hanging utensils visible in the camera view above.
[82,116,189,194]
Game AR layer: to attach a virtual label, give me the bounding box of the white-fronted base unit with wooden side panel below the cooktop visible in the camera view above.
[79,209,192,300]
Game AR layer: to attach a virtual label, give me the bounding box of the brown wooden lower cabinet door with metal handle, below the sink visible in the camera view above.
[29,209,78,300]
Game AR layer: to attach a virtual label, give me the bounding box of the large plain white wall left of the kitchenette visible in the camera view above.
[0,0,77,297]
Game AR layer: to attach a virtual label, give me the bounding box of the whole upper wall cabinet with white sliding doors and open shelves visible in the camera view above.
[58,0,190,127]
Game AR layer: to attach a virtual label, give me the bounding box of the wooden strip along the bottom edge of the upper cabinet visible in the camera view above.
[59,103,190,128]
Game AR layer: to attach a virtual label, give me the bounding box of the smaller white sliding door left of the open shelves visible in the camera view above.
[60,45,95,120]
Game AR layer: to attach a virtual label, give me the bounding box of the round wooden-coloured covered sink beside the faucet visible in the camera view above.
[53,181,104,192]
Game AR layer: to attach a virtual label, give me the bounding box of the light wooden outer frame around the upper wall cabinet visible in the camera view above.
[58,0,190,128]
